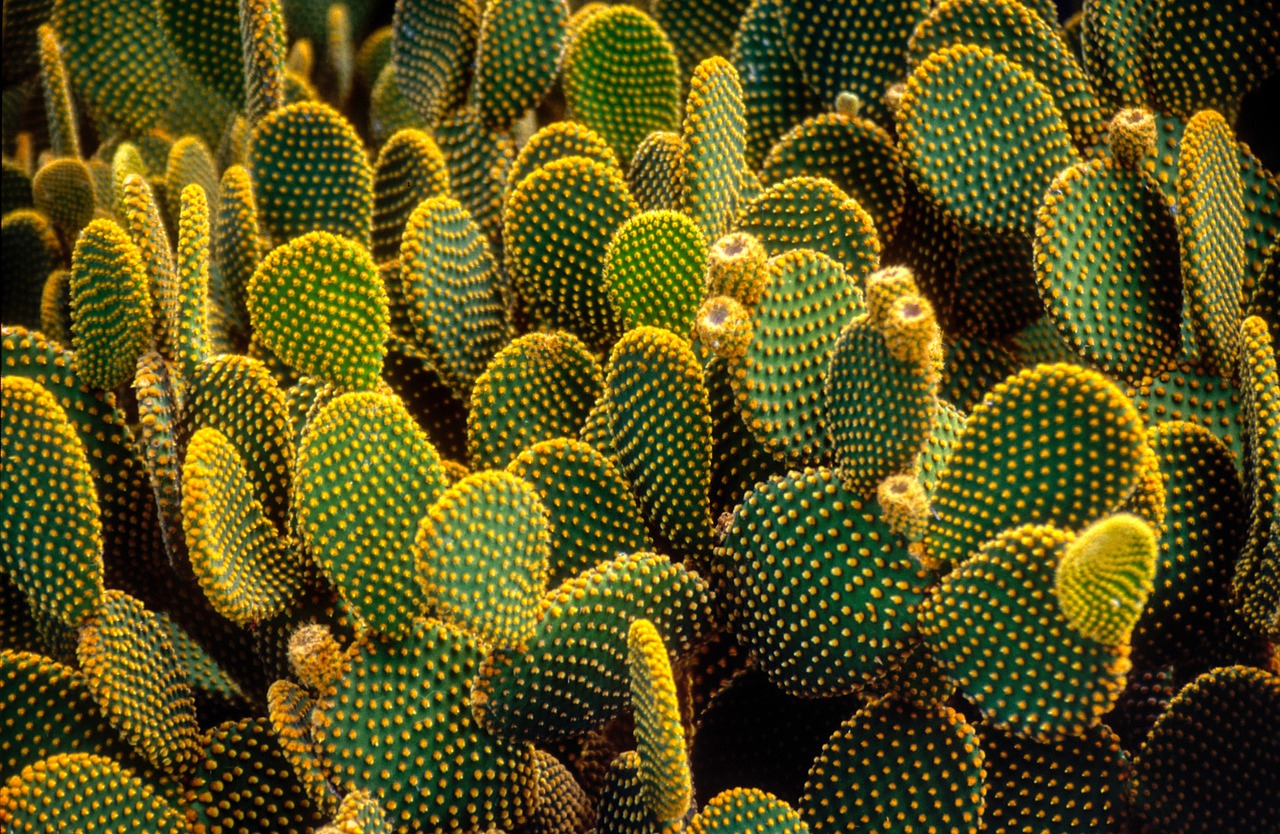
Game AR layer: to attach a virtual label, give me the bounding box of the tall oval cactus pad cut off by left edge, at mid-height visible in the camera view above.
[0,368,104,627]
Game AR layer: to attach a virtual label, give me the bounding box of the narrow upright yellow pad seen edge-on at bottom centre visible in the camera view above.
[627,619,694,822]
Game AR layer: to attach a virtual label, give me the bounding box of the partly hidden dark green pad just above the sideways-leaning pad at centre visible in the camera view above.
[507,437,653,587]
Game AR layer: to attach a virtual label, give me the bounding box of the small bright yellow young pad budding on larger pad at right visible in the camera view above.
[1053,515,1156,646]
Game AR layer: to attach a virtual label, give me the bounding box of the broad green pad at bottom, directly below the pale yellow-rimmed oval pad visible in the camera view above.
[312,619,536,831]
